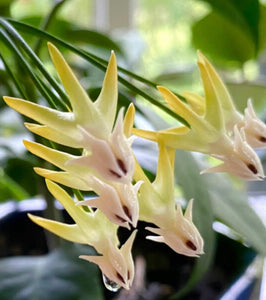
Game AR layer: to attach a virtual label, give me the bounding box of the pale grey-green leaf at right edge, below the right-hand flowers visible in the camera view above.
[204,174,266,256]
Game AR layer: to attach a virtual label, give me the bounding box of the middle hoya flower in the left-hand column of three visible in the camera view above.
[24,141,141,228]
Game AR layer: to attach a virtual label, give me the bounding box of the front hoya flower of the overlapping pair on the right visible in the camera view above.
[133,53,264,180]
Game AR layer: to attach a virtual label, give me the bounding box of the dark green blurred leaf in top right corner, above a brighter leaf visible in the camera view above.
[200,0,260,48]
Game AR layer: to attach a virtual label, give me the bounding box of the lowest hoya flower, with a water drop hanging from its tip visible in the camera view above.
[29,180,136,289]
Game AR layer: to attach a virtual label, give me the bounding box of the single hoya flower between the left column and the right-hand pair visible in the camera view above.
[134,143,203,256]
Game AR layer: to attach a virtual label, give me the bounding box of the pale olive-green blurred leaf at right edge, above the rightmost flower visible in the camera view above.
[226,82,266,114]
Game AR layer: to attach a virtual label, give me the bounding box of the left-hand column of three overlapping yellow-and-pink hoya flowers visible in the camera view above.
[4,44,141,289]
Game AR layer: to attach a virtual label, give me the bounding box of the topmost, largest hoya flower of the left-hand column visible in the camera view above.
[4,43,134,182]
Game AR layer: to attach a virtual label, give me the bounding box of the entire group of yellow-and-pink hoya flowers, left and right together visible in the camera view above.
[4,44,266,289]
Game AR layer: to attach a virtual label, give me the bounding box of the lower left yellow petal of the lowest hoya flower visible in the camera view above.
[28,214,88,244]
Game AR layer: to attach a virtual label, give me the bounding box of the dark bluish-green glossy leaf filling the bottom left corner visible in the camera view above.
[0,243,103,300]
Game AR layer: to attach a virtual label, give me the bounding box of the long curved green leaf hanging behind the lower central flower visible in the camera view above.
[173,150,215,299]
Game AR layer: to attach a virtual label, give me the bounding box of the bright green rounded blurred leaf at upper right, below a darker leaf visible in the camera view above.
[192,12,256,65]
